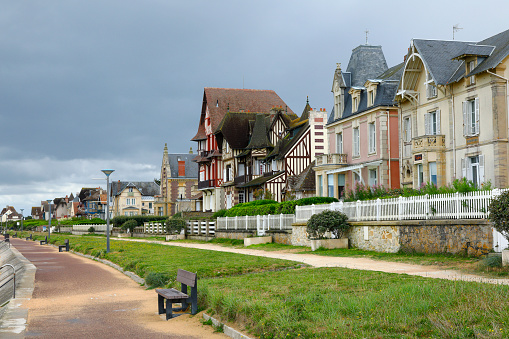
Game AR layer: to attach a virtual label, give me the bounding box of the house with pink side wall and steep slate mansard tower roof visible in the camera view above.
[314,45,403,198]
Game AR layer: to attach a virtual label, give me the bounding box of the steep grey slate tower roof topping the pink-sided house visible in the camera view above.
[343,45,388,86]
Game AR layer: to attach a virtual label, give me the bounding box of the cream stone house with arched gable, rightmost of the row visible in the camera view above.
[396,30,509,188]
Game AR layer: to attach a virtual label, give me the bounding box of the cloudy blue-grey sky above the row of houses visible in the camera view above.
[0,0,509,215]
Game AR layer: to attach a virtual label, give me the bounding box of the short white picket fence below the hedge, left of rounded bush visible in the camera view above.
[217,214,295,235]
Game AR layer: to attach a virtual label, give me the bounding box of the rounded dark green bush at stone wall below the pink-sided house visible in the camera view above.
[306,210,350,239]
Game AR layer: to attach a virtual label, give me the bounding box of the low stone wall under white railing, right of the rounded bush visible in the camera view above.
[348,219,493,256]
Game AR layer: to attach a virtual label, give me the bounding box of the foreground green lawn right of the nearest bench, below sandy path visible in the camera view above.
[199,268,509,338]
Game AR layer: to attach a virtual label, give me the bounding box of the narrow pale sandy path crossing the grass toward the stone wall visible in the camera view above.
[115,238,509,285]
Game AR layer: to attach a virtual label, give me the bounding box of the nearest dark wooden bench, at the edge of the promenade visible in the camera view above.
[156,269,198,320]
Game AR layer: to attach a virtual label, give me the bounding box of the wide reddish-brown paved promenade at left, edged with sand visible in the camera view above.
[7,239,225,338]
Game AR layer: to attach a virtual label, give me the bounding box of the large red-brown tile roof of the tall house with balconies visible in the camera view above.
[191,87,297,141]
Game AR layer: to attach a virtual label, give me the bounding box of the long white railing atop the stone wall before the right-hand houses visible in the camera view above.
[295,189,507,222]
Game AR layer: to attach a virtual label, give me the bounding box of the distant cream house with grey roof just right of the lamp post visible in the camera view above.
[110,180,160,217]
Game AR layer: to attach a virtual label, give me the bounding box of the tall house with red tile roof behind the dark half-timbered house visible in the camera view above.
[191,88,294,211]
